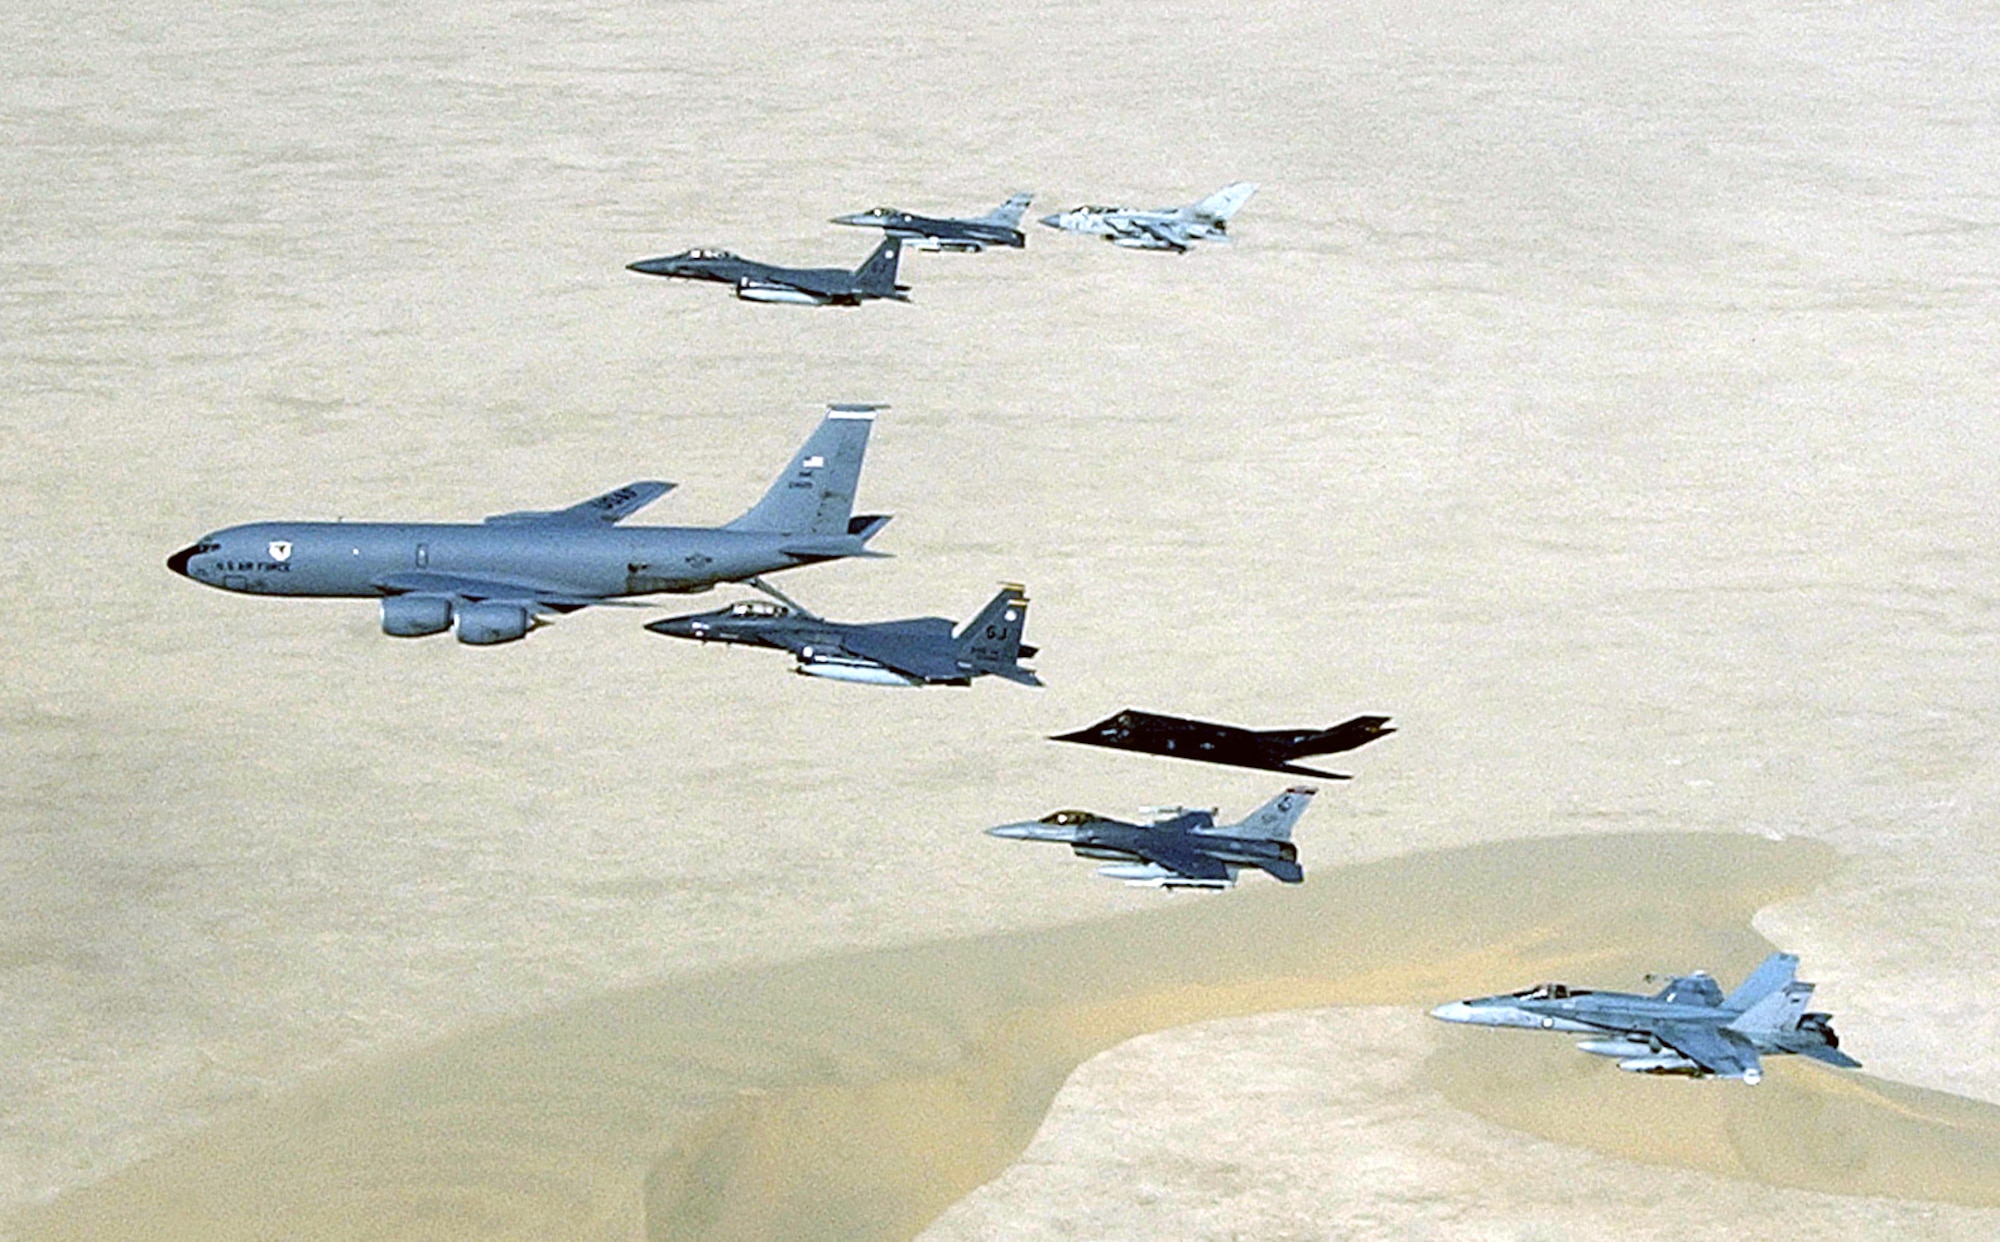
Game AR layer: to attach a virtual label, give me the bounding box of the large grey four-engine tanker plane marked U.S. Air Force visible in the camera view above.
[166,406,888,646]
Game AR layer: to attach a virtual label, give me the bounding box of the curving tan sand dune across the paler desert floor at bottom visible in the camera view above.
[26,834,2000,1242]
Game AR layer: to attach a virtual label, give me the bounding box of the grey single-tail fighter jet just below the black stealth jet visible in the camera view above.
[986,786,1316,888]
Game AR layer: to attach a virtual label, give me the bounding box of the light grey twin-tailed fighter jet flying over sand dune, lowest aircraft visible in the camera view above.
[1430,954,1862,1084]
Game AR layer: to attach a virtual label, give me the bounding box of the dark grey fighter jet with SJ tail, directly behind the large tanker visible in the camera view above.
[646,584,1042,686]
